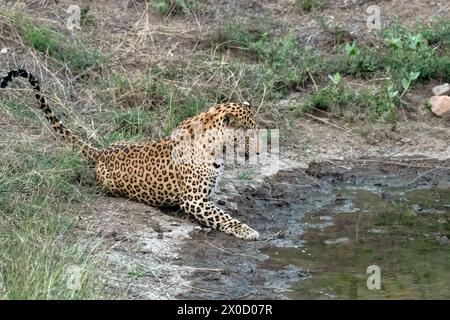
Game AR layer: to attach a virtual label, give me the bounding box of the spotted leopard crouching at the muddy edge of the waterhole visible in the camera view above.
[0,69,260,240]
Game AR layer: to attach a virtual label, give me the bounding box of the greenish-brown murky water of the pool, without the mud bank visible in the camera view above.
[264,187,450,299]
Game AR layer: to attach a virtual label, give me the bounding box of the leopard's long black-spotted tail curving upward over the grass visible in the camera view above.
[0,69,101,162]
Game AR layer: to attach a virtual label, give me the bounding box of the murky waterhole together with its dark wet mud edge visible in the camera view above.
[181,161,450,299]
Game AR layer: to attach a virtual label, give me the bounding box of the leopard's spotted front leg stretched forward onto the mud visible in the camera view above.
[178,165,259,240]
